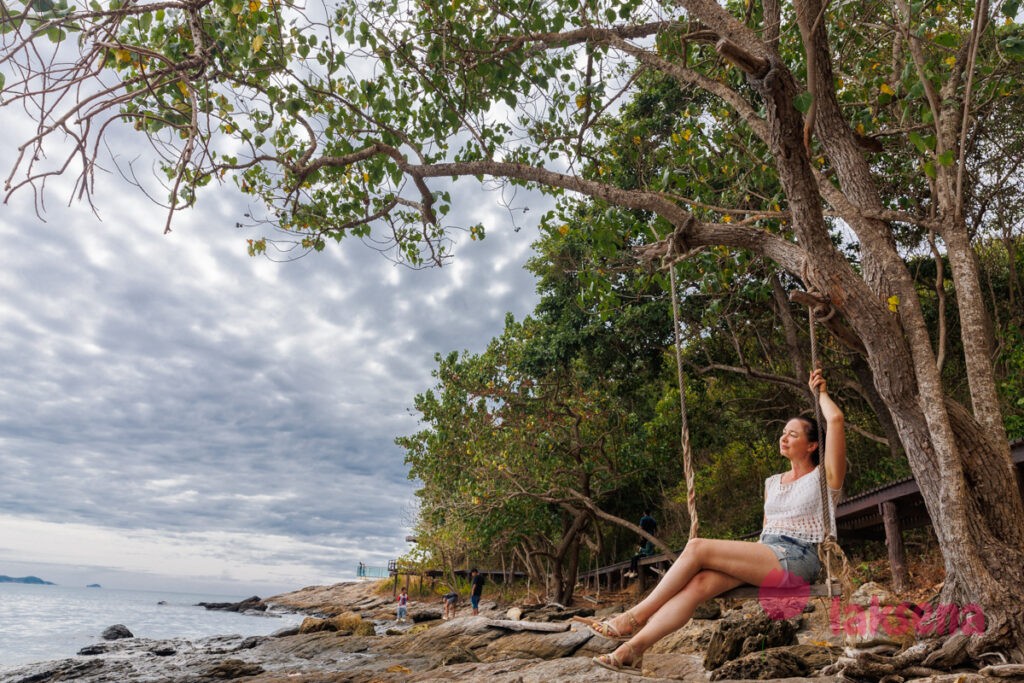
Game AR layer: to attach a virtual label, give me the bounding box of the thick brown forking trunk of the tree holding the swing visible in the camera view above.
[750,10,1024,660]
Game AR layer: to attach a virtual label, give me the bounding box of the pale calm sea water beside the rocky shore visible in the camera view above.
[0,584,303,674]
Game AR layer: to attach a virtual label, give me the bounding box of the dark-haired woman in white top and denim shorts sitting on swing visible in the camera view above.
[586,370,846,671]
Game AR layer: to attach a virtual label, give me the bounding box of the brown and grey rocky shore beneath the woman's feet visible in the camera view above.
[0,584,991,683]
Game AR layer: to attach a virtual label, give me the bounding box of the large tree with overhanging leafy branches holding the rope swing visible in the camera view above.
[0,0,1024,661]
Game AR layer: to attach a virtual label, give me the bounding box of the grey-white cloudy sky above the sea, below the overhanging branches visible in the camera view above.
[0,122,543,597]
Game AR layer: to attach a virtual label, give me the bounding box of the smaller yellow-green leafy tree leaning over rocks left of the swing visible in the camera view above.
[397,313,667,603]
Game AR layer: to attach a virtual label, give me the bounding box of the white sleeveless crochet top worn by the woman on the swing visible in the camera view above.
[761,467,843,543]
